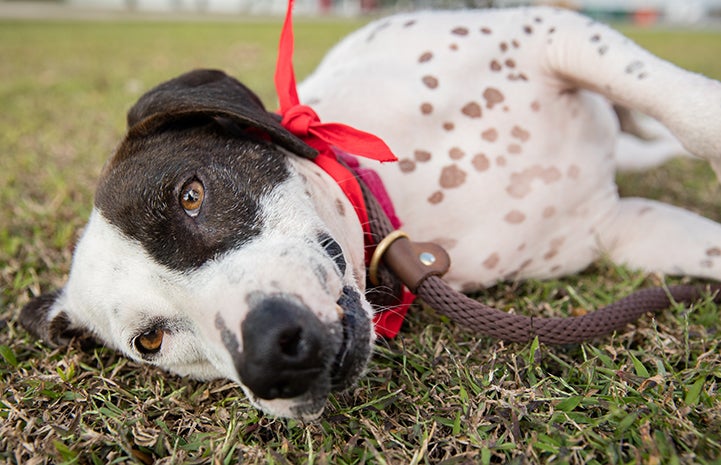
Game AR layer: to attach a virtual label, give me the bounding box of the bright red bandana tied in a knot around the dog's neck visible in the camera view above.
[275,0,414,337]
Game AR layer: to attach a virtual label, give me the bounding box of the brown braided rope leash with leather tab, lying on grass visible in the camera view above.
[359,172,721,344]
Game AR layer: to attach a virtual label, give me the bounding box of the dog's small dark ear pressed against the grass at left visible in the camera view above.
[20,290,92,347]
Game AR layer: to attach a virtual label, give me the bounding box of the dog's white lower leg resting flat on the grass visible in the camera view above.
[597,198,721,280]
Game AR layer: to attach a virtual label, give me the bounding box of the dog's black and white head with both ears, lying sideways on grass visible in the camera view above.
[20,70,373,419]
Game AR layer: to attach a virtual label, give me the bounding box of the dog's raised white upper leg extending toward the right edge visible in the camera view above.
[545,12,721,179]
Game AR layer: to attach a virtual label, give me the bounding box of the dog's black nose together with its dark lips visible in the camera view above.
[235,288,371,401]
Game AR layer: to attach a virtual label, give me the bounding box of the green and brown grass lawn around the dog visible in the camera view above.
[0,13,721,464]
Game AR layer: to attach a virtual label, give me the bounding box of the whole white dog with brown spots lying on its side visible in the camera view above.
[20,7,721,420]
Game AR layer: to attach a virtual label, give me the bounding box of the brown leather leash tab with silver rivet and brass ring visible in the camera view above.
[368,230,451,293]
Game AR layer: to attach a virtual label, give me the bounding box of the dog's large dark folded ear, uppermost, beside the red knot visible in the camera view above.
[128,69,317,158]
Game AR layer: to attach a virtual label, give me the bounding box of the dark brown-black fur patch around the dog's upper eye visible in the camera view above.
[95,121,289,271]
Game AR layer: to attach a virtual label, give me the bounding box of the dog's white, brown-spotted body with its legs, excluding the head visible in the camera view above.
[300,9,721,290]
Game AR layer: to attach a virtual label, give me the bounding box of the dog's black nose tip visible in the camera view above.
[236,297,327,399]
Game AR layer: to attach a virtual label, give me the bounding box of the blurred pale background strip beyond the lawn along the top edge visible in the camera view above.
[0,0,721,25]
